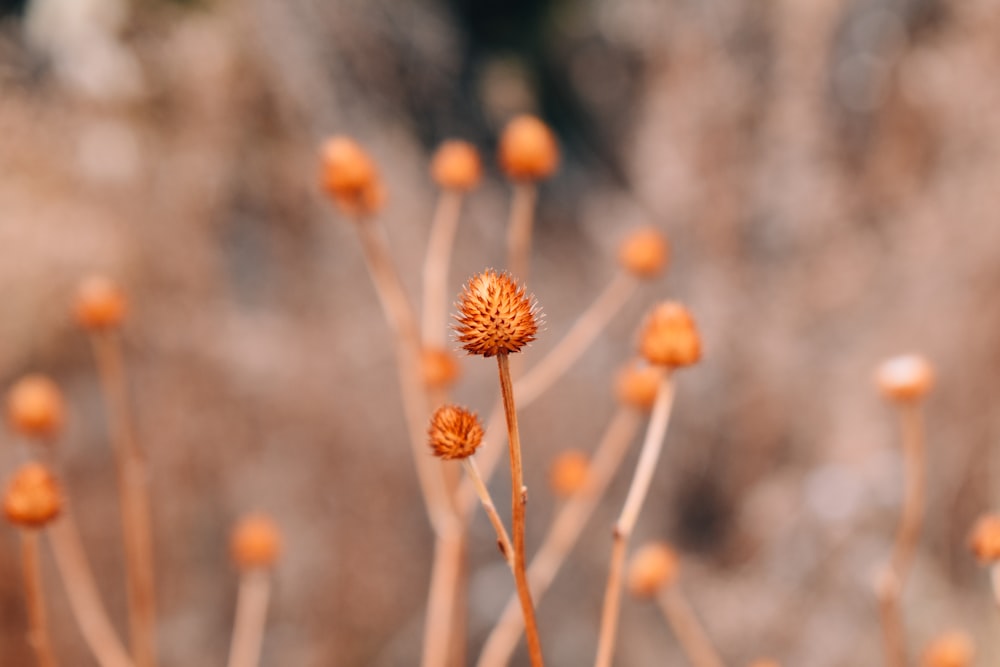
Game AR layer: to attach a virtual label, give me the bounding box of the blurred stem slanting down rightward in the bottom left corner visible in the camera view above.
[47,512,132,667]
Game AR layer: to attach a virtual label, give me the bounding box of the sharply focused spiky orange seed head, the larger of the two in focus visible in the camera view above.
[455,269,538,357]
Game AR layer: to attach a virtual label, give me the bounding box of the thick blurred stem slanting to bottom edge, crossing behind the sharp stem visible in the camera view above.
[477,406,640,667]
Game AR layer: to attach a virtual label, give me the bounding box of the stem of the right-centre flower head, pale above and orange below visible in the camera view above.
[594,372,674,667]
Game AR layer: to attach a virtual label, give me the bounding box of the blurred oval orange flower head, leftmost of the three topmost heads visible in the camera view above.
[321,136,385,218]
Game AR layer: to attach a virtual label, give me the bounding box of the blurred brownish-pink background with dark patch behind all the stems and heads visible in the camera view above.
[0,0,1000,667]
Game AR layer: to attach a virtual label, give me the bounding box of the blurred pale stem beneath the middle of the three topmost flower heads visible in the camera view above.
[422,190,462,347]
